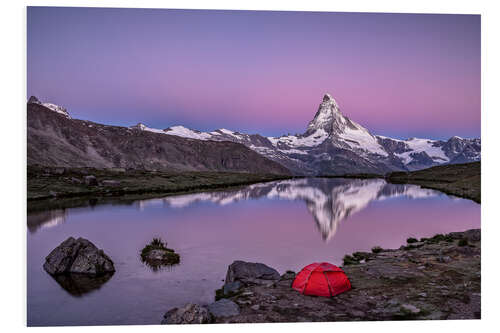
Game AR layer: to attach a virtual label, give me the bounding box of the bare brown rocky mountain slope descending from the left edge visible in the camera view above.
[27,97,289,174]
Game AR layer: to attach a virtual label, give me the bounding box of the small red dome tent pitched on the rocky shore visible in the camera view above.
[292,262,351,297]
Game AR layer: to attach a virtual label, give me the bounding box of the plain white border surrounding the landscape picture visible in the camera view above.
[0,0,500,333]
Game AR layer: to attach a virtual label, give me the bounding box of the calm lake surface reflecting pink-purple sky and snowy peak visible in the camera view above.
[27,178,480,326]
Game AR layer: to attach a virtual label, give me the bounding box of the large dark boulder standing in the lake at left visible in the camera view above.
[43,237,115,275]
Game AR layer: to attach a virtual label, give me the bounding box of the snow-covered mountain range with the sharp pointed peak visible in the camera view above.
[131,94,481,175]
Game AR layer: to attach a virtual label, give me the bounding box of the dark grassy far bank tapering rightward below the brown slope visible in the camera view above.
[27,165,296,201]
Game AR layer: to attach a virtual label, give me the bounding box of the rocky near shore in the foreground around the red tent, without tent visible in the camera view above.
[162,229,481,324]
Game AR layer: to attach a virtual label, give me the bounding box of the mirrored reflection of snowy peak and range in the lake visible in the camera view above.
[137,178,441,241]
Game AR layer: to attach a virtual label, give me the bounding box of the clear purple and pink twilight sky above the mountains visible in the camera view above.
[27,7,481,139]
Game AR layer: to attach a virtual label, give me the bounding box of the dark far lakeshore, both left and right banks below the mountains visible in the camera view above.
[27,162,481,212]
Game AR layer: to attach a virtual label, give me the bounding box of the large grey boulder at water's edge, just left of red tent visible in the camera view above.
[225,260,280,285]
